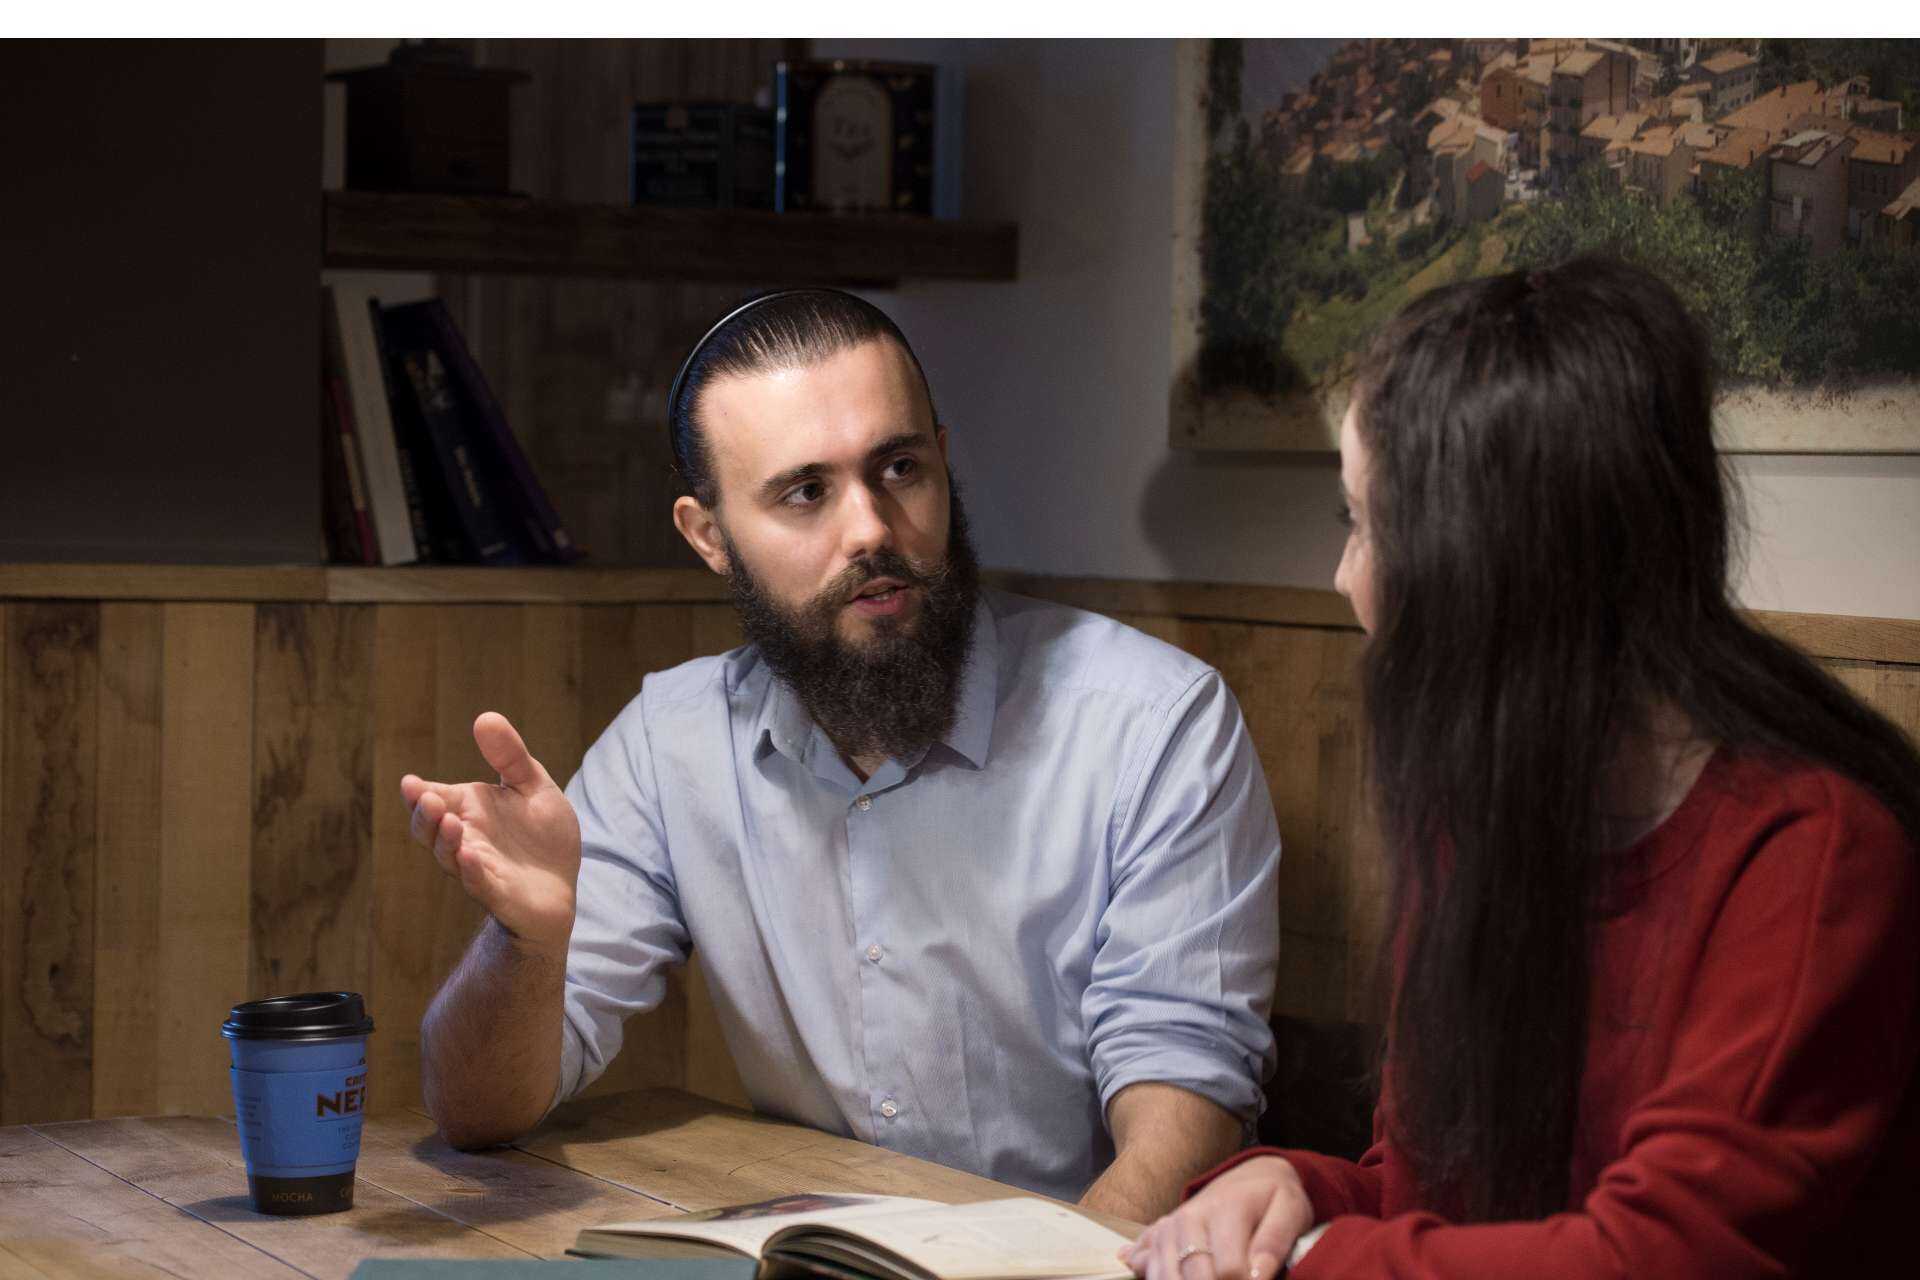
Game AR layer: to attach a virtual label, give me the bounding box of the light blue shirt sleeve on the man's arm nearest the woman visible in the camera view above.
[1081,670,1281,1121]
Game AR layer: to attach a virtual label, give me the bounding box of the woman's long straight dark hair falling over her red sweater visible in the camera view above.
[1356,257,1920,1221]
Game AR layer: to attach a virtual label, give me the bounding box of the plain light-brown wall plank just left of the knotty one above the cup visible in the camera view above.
[154,604,265,1113]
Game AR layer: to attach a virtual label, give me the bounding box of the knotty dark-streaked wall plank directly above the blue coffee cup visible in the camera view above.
[250,604,374,996]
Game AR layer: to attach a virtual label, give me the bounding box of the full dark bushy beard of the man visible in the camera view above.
[722,476,979,760]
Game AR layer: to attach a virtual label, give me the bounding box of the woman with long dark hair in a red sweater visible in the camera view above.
[1123,259,1920,1280]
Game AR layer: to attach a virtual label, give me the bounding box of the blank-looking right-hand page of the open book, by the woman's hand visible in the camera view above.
[772,1197,1133,1280]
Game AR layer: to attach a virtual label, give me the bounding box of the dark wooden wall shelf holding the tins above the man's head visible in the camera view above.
[324,192,1020,286]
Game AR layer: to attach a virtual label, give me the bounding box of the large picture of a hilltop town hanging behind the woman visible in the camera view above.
[1169,38,1920,453]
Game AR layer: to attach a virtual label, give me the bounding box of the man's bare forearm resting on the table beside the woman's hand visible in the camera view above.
[1081,1082,1240,1222]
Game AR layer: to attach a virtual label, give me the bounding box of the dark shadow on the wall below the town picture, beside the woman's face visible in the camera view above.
[1140,451,1346,589]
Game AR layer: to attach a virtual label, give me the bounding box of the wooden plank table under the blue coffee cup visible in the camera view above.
[0,1090,1131,1280]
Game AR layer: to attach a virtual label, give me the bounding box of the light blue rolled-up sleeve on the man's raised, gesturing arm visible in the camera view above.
[555,685,687,1103]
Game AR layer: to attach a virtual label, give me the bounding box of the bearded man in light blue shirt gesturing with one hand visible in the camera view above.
[401,290,1279,1221]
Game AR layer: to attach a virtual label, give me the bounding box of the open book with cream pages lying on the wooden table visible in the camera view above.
[570,1196,1133,1280]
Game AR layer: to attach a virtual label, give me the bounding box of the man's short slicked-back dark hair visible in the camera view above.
[666,288,939,507]
